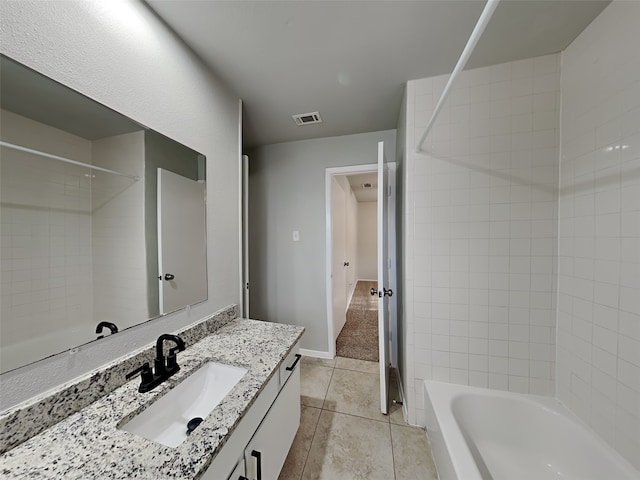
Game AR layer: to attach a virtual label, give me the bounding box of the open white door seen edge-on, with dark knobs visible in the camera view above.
[378,142,393,415]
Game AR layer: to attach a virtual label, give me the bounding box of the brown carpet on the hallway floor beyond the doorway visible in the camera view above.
[336,280,378,362]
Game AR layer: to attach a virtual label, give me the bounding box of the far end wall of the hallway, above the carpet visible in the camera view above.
[357,202,378,280]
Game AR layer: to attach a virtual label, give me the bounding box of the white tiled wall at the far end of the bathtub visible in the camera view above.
[404,55,560,425]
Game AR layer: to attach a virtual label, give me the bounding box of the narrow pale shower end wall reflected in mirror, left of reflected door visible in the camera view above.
[91,130,149,329]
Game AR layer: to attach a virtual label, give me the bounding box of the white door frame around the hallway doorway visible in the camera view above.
[324,162,398,366]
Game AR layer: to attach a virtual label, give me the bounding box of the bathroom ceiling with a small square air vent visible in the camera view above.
[147,0,609,147]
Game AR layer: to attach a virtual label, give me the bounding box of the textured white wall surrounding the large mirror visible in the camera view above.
[0,0,239,409]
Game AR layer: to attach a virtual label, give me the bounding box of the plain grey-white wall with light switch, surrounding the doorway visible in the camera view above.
[249,127,395,352]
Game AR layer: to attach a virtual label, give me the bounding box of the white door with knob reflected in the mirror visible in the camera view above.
[158,168,207,314]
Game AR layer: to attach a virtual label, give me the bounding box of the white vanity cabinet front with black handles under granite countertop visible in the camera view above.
[198,344,300,480]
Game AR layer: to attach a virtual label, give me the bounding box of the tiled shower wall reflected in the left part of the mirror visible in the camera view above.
[0,110,93,371]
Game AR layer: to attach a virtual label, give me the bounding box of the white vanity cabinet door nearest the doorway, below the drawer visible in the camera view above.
[244,365,300,480]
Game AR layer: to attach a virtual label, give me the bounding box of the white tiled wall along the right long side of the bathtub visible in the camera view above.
[557,1,640,468]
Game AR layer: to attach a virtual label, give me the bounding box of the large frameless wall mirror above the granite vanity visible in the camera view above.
[0,56,207,373]
